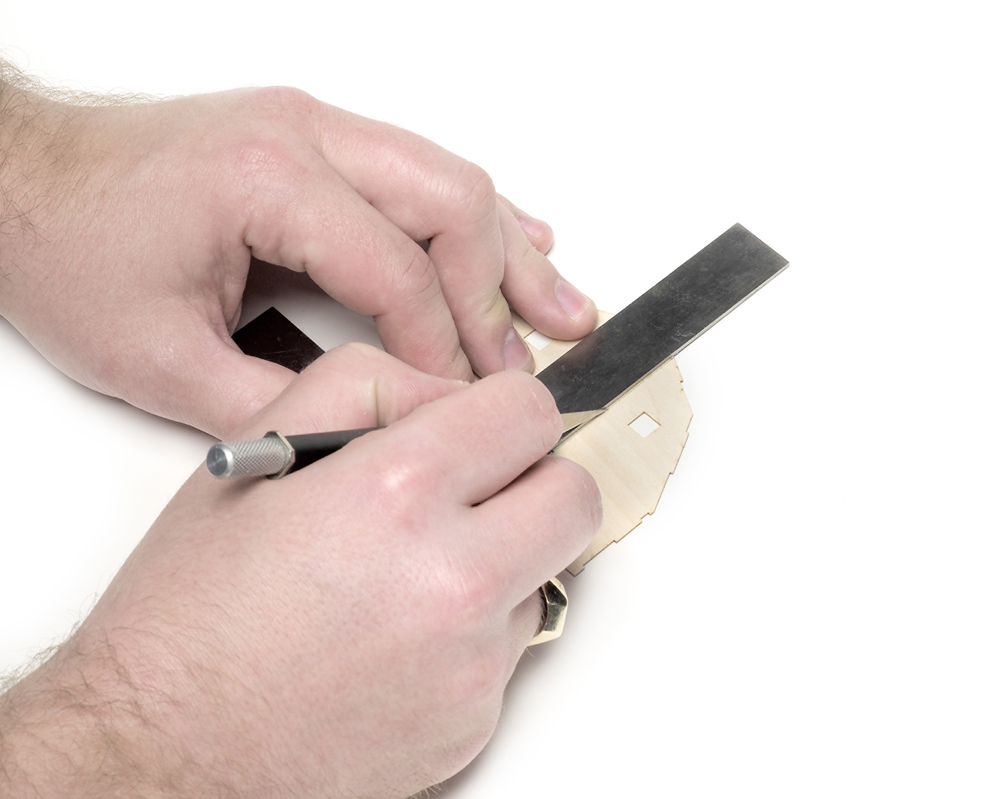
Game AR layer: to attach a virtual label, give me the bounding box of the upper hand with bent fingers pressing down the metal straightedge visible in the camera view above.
[0,70,596,436]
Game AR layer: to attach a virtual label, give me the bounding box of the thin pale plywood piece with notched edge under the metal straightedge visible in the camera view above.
[514,312,691,576]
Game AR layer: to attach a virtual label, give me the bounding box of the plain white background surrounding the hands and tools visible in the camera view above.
[0,0,1000,799]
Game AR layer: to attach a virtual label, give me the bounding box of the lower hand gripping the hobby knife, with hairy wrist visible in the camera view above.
[0,345,601,798]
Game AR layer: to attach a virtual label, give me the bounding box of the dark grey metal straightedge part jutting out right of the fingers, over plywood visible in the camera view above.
[538,225,788,413]
